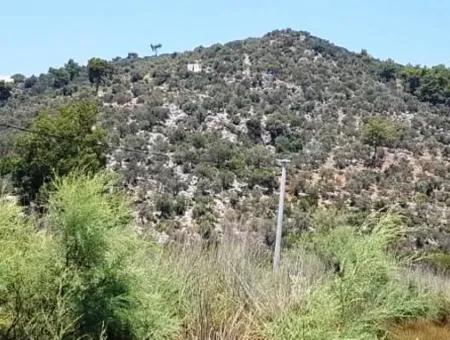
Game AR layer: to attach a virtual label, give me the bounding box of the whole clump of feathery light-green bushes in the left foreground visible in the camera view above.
[0,174,185,339]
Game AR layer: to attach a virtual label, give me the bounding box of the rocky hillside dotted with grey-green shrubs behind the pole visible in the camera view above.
[0,30,450,262]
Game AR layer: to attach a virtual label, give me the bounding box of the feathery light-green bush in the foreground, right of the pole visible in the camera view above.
[269,215,438,340]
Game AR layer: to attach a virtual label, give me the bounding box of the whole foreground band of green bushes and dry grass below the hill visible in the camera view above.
[0,173,448,340]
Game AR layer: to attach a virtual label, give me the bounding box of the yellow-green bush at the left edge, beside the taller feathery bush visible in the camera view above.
[0,198,70,340]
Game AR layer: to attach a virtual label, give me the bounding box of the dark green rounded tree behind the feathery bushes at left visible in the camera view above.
[5,102,108,202]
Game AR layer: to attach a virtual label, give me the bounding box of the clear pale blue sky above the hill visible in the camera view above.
[0,0,450,75]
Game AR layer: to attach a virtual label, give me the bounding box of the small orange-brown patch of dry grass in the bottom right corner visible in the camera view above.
[389,321,450,340]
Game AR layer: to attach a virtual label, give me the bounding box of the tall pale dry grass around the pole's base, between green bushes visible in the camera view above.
[168,234,325,340]
